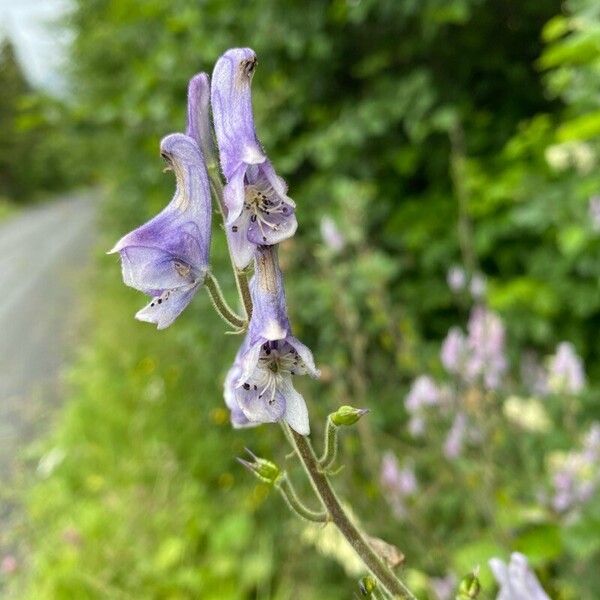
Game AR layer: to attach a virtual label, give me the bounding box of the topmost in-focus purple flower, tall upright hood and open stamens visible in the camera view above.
[211,48,297,269]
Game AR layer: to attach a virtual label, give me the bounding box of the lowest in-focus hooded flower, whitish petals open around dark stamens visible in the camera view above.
[225,246,319,435]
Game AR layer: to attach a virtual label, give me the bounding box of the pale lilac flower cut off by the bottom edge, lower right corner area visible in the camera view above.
[489,552,550,600]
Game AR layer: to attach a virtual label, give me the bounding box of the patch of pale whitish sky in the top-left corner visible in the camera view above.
[0,0,70,93]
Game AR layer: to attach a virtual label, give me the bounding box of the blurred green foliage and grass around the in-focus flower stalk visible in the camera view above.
[0,0,600,599]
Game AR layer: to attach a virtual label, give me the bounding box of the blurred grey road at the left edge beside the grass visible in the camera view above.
[0,195,95,494]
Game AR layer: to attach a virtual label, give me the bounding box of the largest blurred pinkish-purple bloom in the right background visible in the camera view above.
[465,306,508,390]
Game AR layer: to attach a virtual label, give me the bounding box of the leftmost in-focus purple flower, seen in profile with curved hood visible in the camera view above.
[110,133,211,329]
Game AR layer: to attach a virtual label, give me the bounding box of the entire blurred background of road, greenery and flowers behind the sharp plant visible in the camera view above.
[0,0,600,600]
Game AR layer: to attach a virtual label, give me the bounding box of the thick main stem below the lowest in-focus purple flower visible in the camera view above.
[290,430,416,600]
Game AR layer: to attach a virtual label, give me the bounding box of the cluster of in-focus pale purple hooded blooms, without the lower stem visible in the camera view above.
[111,48,319,435]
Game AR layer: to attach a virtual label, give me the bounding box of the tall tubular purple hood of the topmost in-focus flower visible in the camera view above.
[211,48,265,180]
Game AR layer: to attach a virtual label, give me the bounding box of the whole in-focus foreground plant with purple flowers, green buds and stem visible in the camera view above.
[112,48,422,599]
